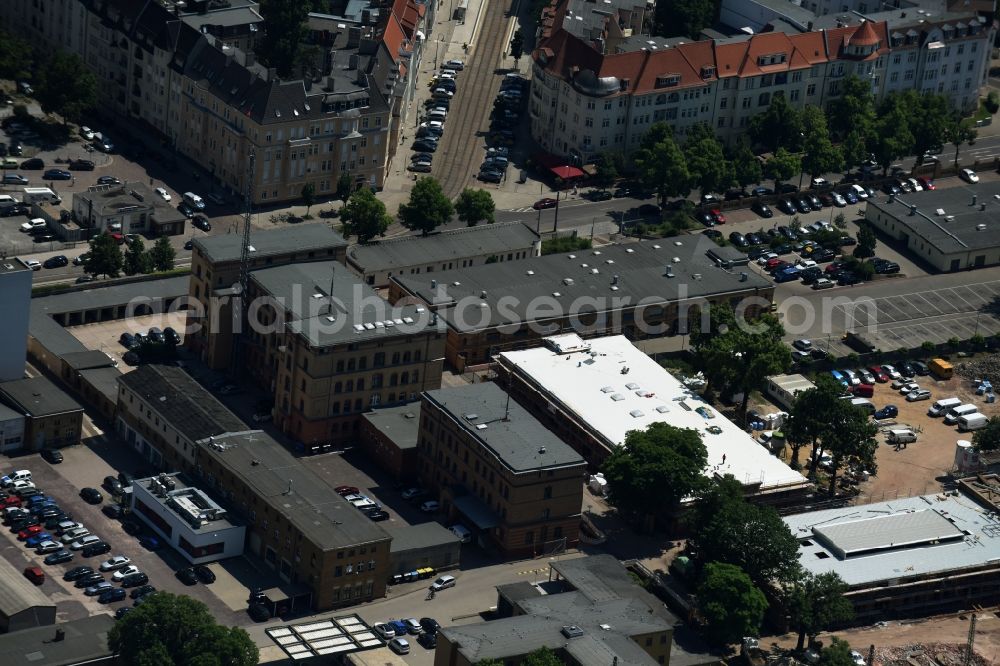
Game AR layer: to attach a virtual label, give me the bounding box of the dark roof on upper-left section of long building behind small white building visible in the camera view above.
[118,365,248,442]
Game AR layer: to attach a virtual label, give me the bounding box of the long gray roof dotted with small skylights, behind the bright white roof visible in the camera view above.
[392,234,773,331]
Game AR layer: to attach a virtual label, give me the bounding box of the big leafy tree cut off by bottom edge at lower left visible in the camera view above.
[108,592,259,666]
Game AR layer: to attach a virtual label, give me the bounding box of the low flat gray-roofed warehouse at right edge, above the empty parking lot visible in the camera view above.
[865,183,1000,273]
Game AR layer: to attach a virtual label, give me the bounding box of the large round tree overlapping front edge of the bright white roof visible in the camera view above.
[604,423,708,516]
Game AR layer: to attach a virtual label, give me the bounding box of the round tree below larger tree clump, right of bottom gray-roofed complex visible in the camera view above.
[698,562,767,645]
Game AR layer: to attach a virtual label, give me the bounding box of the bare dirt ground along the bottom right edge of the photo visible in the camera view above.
[760,609,1000,666]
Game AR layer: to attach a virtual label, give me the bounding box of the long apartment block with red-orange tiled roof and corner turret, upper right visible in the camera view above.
[529,0,995,162]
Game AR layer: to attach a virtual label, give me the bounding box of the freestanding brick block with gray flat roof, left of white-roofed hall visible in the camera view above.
[417,382,587,556]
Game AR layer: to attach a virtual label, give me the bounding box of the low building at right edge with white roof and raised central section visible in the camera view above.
[783,477,1000,624]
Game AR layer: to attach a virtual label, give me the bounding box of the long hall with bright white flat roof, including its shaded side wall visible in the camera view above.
[496,333,811,505]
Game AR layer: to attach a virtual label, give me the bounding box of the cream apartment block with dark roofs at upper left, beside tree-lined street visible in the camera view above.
[0,0,422,203]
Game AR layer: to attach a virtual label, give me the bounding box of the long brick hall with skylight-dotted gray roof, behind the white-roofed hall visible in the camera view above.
[389,234,774,371]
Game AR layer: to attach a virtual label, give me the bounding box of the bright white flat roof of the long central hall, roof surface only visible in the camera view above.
[500,335,807,489]
